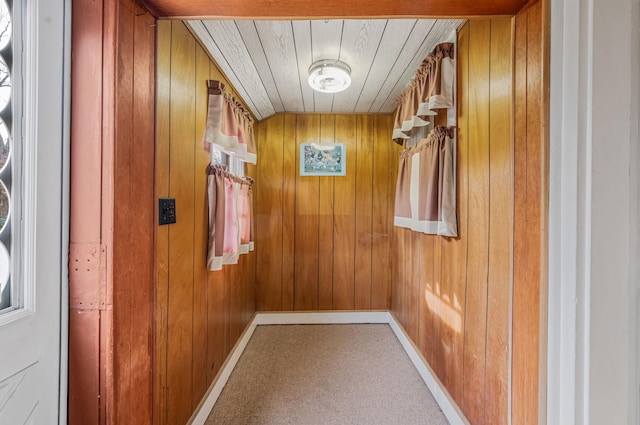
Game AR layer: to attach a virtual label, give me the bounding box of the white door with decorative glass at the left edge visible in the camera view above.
[0,0,70,425]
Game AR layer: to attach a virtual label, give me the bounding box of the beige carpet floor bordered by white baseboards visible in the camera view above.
[206,325,448,425]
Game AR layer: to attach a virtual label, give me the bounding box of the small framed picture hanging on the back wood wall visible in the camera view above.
[300,143,347,176]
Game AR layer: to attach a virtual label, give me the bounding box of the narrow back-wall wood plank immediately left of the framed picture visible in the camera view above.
[282,114,300,311]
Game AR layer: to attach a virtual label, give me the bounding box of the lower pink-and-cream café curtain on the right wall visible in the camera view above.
[394,126,458,236]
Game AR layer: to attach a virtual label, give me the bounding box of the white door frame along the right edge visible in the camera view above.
[547,0,640,424]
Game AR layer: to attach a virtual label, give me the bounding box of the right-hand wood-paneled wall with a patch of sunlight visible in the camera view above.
[392,7,549,424]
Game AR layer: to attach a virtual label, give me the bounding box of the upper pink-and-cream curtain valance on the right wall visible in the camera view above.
[392,43,455,145]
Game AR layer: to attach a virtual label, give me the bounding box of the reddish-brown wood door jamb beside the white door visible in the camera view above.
[68,0,155,424]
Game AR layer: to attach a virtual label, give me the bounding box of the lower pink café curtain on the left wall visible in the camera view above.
[207,165,253,270]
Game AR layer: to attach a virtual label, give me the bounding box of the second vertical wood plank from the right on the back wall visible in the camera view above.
[354,115,375,310]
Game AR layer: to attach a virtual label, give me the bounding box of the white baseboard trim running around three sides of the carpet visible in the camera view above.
[188,311,469,425]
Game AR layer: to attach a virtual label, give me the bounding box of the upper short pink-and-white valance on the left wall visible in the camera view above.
[204,80,257,164]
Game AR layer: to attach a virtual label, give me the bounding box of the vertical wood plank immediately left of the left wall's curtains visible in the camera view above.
[192,45,210,408]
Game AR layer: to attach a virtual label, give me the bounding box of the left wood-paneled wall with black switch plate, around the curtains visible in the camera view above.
[154,21,256,424]
